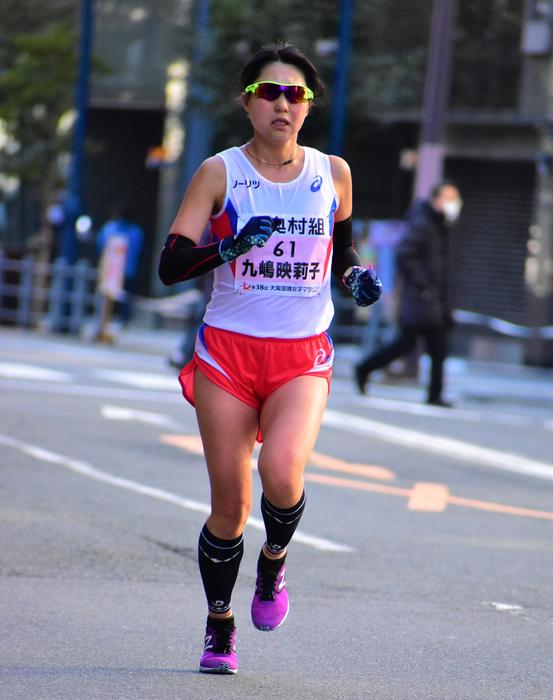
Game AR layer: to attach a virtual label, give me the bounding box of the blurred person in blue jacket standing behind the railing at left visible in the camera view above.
[96,203,144,326]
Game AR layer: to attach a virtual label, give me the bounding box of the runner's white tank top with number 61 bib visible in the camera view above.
[204,147,338,338]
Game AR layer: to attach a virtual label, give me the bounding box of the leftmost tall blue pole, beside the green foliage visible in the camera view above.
[60,0,94,263]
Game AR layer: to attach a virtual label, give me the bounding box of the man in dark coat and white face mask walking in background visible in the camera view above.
[355,182,462,407]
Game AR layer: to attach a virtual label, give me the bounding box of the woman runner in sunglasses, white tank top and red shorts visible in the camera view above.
[155,44,381,673]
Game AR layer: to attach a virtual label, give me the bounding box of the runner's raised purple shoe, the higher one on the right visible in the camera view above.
[252,552,290,632]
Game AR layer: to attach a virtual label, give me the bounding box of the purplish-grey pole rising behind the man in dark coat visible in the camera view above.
[415,0,457,197]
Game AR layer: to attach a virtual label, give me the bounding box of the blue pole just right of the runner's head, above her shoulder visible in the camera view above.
[329,0,353,155]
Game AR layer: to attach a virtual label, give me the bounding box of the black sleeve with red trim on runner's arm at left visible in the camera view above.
[158,233,224,285]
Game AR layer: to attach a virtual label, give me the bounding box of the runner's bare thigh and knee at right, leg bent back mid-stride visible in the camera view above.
[259,376,328,508]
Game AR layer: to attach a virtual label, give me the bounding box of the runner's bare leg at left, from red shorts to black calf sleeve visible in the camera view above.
[194,370,258,539]
